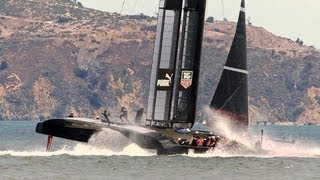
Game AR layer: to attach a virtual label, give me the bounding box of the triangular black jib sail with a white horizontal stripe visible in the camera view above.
[210,0,249,127]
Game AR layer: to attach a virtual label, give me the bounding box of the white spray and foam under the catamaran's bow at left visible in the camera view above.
[0,130,156,157]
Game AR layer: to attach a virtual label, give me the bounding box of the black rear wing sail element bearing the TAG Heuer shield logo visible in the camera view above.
[172,0,206,125]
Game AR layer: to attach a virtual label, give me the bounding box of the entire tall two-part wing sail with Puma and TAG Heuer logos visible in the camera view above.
[147,0,206,126]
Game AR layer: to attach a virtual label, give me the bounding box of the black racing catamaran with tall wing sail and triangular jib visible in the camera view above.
[36,0,249,154]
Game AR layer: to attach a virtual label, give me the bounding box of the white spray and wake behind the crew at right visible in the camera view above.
[188,108,320,158]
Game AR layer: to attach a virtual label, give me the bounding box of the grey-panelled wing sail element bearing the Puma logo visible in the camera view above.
[147,0,183,125]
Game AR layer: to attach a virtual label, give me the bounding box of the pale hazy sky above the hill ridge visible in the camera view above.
[78,0,320,48]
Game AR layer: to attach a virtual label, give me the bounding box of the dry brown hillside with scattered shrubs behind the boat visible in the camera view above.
[0,0,320,124]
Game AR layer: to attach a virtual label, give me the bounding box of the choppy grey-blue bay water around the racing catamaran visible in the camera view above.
[0,121,320,180]
